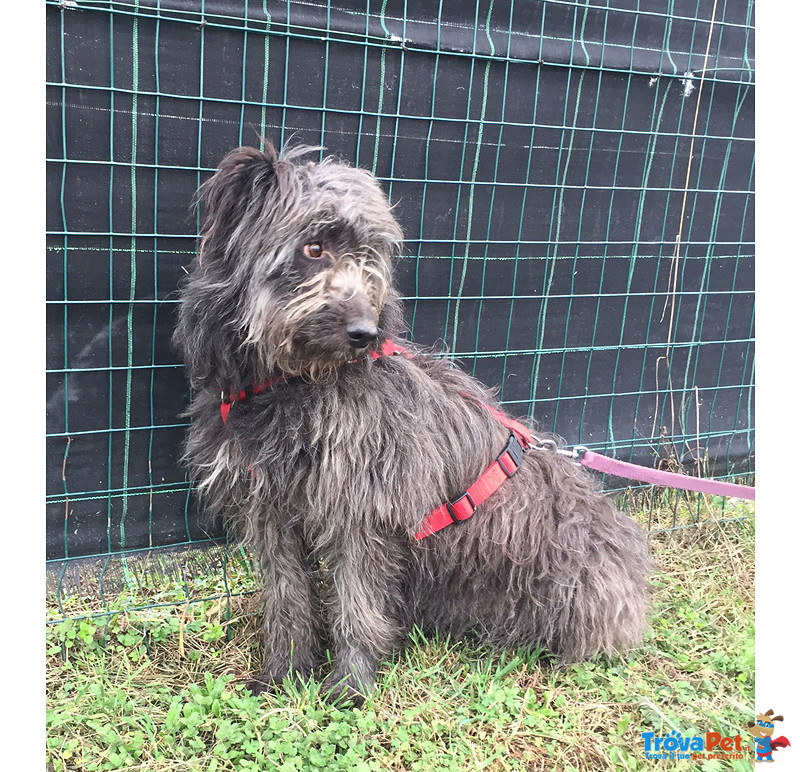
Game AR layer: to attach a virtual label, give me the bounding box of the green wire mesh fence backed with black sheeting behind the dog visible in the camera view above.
[47,0,754,619]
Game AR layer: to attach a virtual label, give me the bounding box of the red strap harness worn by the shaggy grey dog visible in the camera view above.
[219,340,535,541]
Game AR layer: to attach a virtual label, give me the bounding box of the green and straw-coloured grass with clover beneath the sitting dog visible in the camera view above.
[46,500,754,772]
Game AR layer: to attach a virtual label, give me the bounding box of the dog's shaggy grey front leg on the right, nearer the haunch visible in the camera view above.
[325,535,408,705]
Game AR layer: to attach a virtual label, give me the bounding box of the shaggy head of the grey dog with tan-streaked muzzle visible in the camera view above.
[175,145,402,388]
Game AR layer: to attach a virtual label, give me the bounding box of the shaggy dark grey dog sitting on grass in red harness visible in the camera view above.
[174,140,650,701]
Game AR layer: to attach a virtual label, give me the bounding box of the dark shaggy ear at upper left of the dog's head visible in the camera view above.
[195,143,277,252]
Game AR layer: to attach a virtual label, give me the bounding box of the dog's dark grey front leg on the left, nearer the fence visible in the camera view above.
[248,522,321,694]
